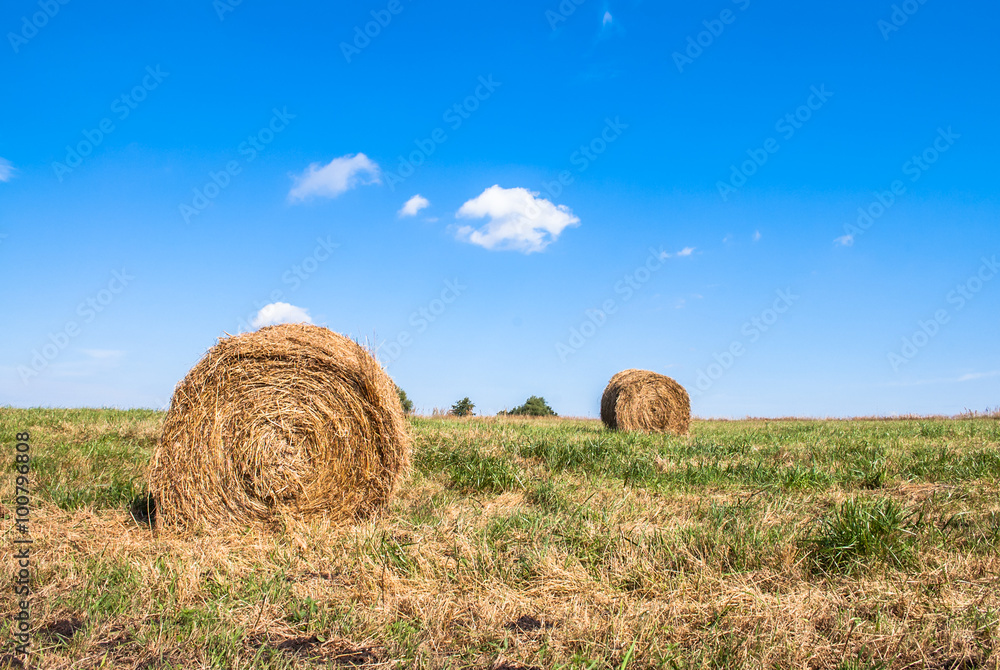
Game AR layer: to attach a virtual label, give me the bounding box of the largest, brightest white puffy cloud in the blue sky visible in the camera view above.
[455,185,580,254]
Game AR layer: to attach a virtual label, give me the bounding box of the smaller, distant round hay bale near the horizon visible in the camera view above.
[601,370,691,435]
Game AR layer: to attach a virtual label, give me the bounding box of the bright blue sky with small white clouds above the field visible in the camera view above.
[0,0,1000,417]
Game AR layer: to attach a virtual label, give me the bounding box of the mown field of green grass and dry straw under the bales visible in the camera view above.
[0,409,1000,670]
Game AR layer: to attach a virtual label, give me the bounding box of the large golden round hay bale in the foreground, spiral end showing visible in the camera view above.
[149,324,410,527]
